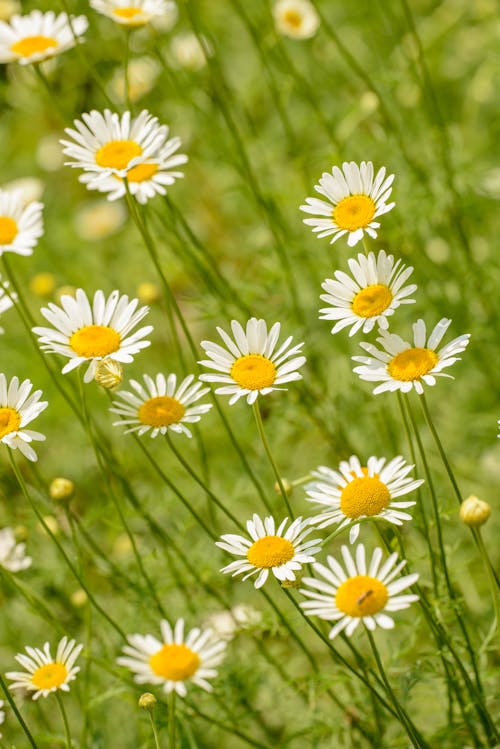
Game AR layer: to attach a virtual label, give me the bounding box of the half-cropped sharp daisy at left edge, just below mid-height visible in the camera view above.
[0,374,48,461]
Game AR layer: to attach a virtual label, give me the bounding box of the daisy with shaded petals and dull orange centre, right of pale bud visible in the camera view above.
[109,374,212,437]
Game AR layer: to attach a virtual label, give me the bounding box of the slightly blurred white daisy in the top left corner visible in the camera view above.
[0,10,88,65]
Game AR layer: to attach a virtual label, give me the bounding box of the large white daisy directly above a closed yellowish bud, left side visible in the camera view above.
[33,289,153,382]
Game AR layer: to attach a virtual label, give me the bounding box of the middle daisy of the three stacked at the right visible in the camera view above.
[319,250,417,336]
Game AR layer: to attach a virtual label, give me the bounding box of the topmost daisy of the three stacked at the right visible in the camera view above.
[300,161,396,247]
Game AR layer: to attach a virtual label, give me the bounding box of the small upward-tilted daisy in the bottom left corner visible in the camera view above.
[5,637,83,700]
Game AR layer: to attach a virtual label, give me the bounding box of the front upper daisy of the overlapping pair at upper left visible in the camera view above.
[60,109,174,182]
